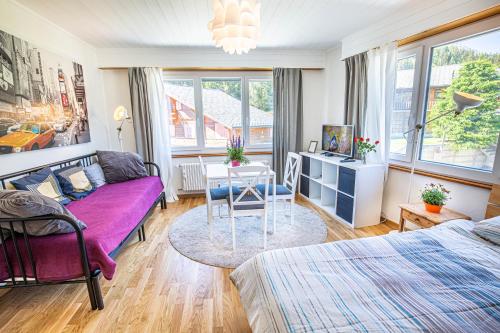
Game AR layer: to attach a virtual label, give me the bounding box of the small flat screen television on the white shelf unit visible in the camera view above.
[321,125,354,157]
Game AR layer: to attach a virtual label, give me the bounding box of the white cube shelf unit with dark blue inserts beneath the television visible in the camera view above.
[299,152,385,228]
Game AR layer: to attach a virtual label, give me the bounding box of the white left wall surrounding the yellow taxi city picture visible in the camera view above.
[0,0,108,174]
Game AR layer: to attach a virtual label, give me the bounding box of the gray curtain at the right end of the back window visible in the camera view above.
[273,68,302,183]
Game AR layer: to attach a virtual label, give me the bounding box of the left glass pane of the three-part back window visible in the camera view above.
[164,80,197,147]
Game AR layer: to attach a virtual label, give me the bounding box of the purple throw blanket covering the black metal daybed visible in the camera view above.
[0,177,163,281]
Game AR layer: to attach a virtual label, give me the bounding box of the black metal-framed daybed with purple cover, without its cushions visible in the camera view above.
[0,154,166,309]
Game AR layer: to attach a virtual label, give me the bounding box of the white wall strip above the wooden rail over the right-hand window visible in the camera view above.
[342,0,498,59]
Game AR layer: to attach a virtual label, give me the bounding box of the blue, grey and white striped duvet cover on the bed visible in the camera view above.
[231,220,500,333]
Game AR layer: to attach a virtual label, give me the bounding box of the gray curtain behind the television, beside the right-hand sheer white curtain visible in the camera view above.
[344,52,367,137]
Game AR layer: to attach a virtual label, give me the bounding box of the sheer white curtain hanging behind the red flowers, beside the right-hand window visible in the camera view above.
[363,43,397,164]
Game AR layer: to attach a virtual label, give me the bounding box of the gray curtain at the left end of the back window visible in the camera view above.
[128,67,154,161]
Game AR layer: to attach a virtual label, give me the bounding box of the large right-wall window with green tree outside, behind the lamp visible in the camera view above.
[390,20,500,182]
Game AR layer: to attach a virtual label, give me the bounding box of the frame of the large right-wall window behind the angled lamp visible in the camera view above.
[390,17,500,183]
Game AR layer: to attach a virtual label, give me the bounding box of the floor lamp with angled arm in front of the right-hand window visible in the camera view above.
[403,92,483,203]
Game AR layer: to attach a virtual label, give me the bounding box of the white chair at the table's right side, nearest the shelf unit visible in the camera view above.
[257,152,302,224]
